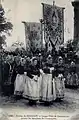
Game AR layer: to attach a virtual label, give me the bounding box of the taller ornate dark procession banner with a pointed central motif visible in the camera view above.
[42,3,64,49]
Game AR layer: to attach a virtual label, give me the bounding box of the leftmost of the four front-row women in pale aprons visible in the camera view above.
[14,58,25,100]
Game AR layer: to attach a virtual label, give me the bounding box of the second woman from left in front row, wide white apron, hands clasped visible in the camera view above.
[23,57,40,105]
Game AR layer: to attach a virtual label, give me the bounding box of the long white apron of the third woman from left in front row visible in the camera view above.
[41,74,53,102]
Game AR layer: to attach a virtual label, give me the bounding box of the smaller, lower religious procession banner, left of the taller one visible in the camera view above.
[22,22,42,51]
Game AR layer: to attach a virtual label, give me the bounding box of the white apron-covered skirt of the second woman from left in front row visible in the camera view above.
[23,76,39,100]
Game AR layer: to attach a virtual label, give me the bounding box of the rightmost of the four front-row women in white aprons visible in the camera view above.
[53,56,65,101]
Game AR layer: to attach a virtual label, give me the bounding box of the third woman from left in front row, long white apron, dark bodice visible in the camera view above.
[41,55,54,105]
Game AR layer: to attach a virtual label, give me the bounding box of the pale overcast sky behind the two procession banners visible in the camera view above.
[2,0,74,46]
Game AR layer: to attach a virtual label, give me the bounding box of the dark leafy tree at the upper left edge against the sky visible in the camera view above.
[0,4,13,48]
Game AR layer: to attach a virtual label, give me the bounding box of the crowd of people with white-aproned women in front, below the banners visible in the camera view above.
[1,42,79,105]
